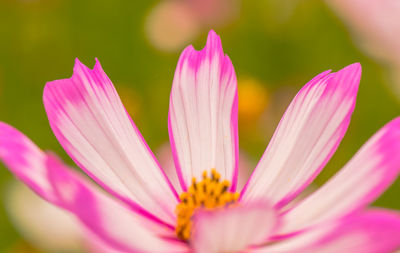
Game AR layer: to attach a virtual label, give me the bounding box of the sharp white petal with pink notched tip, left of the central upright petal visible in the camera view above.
[43,59,178,224]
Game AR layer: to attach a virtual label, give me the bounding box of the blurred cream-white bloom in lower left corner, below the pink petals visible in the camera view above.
[5,182,84,252]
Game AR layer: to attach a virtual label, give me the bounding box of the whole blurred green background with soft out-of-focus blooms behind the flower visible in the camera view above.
[0,0,400,253]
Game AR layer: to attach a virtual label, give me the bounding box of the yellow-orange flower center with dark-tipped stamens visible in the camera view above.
[175,169,239,240]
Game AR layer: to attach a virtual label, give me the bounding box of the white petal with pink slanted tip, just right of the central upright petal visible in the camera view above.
[242,63,361,207]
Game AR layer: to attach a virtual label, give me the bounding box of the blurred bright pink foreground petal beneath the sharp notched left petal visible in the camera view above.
[49,156,188,252]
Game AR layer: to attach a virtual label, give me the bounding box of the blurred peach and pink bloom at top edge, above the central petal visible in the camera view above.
[145,0,239,52]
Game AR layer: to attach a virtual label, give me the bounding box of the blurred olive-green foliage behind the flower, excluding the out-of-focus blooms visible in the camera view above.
[0,0,400,252]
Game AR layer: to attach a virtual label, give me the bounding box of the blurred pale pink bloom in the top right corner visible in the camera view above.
[326,0,400,96]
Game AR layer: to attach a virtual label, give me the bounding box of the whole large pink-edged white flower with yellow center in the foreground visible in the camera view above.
[0,32,400,252]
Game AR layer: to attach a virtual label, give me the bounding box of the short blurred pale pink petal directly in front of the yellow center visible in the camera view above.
[190,202,278,253]
